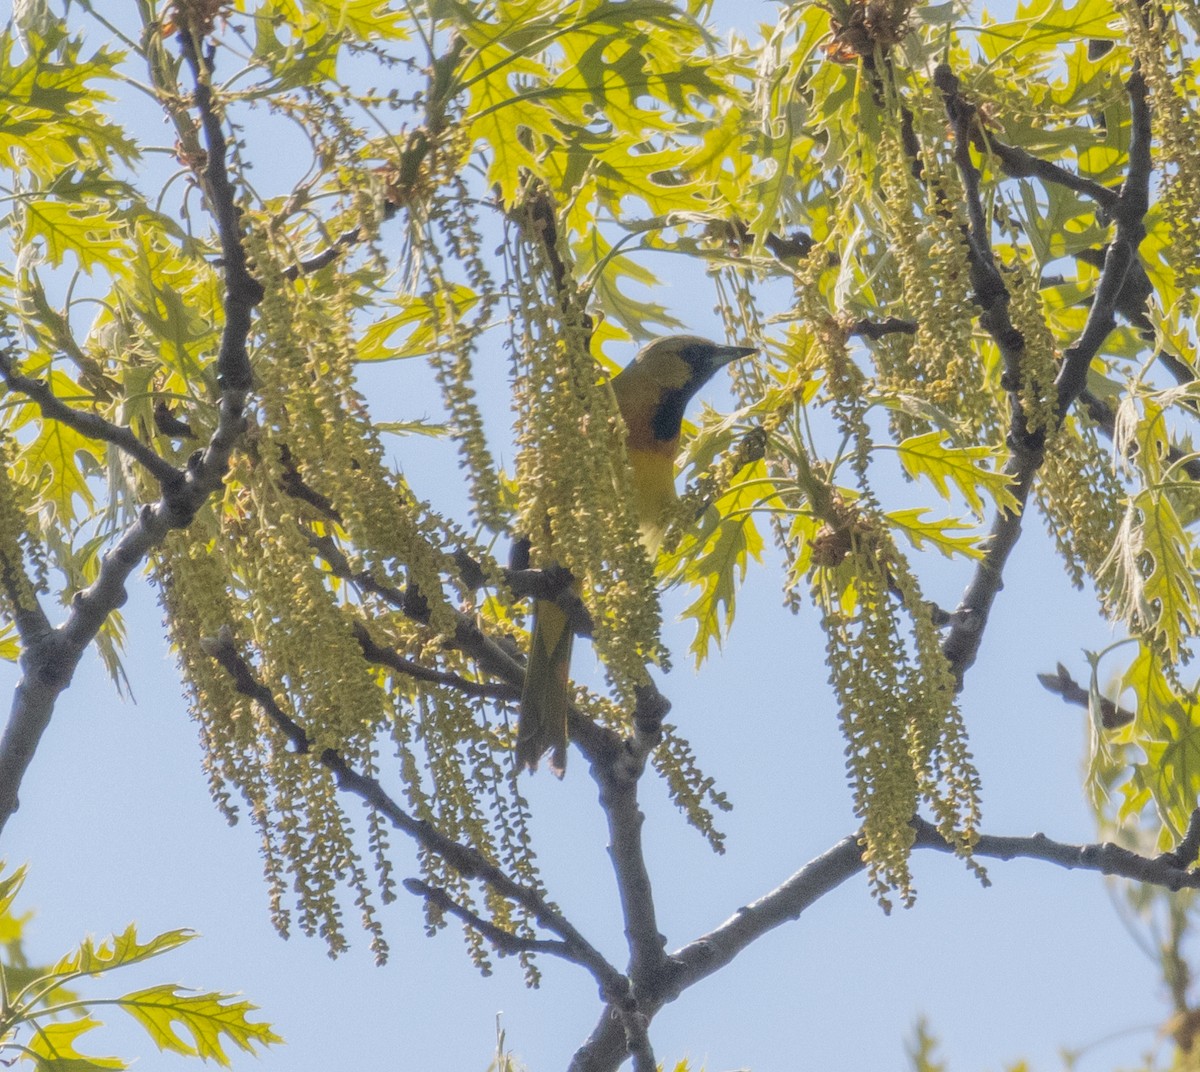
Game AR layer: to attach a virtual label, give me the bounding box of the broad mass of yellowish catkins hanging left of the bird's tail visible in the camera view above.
[156,224,534,971]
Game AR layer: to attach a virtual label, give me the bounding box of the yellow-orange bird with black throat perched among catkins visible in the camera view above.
[516,335,757,778]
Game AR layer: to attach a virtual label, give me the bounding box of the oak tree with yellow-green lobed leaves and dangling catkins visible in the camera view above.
[0,0,1200,1072]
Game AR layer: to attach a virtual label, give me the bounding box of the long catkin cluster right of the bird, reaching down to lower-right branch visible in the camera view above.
[776,247,982,908]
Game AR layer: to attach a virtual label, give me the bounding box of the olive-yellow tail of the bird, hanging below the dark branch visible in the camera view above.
[516,599,575,778]
